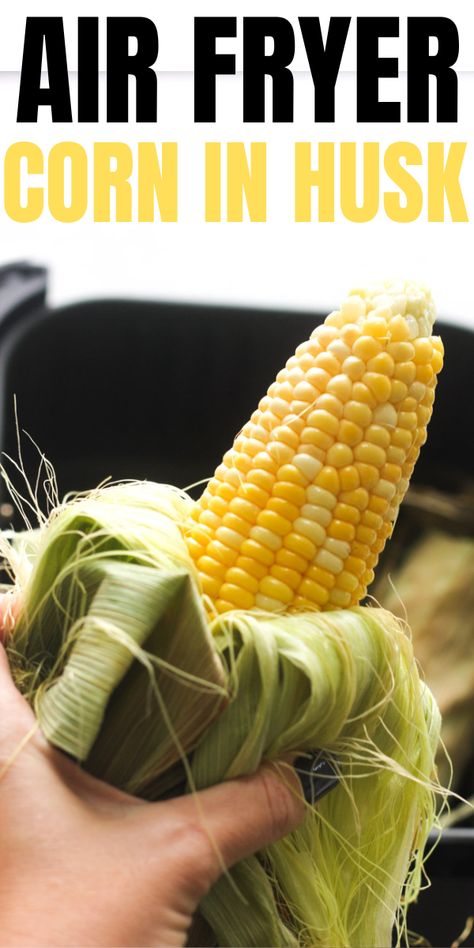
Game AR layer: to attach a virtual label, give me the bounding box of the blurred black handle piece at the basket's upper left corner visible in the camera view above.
[0,262,48,332]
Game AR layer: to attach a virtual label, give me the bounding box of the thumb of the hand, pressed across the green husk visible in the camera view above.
[161,764,305,885]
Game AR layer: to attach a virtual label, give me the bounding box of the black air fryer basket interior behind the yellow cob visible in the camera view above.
[0,268,468,512]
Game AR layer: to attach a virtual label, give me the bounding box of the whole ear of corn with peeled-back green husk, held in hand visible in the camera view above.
[3,278,442,948]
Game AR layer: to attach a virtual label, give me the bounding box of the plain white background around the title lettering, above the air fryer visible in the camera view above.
[0,0,474,327]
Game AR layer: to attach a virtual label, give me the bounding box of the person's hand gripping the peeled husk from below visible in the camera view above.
[0,600,304,948]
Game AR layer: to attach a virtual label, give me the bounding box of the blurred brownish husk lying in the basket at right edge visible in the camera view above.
[371,486,474,788]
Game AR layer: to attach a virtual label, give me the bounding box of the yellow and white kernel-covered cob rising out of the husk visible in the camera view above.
[187,284,443,612]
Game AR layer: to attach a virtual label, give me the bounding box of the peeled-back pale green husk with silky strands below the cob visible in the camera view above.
[1,483,439,948]
